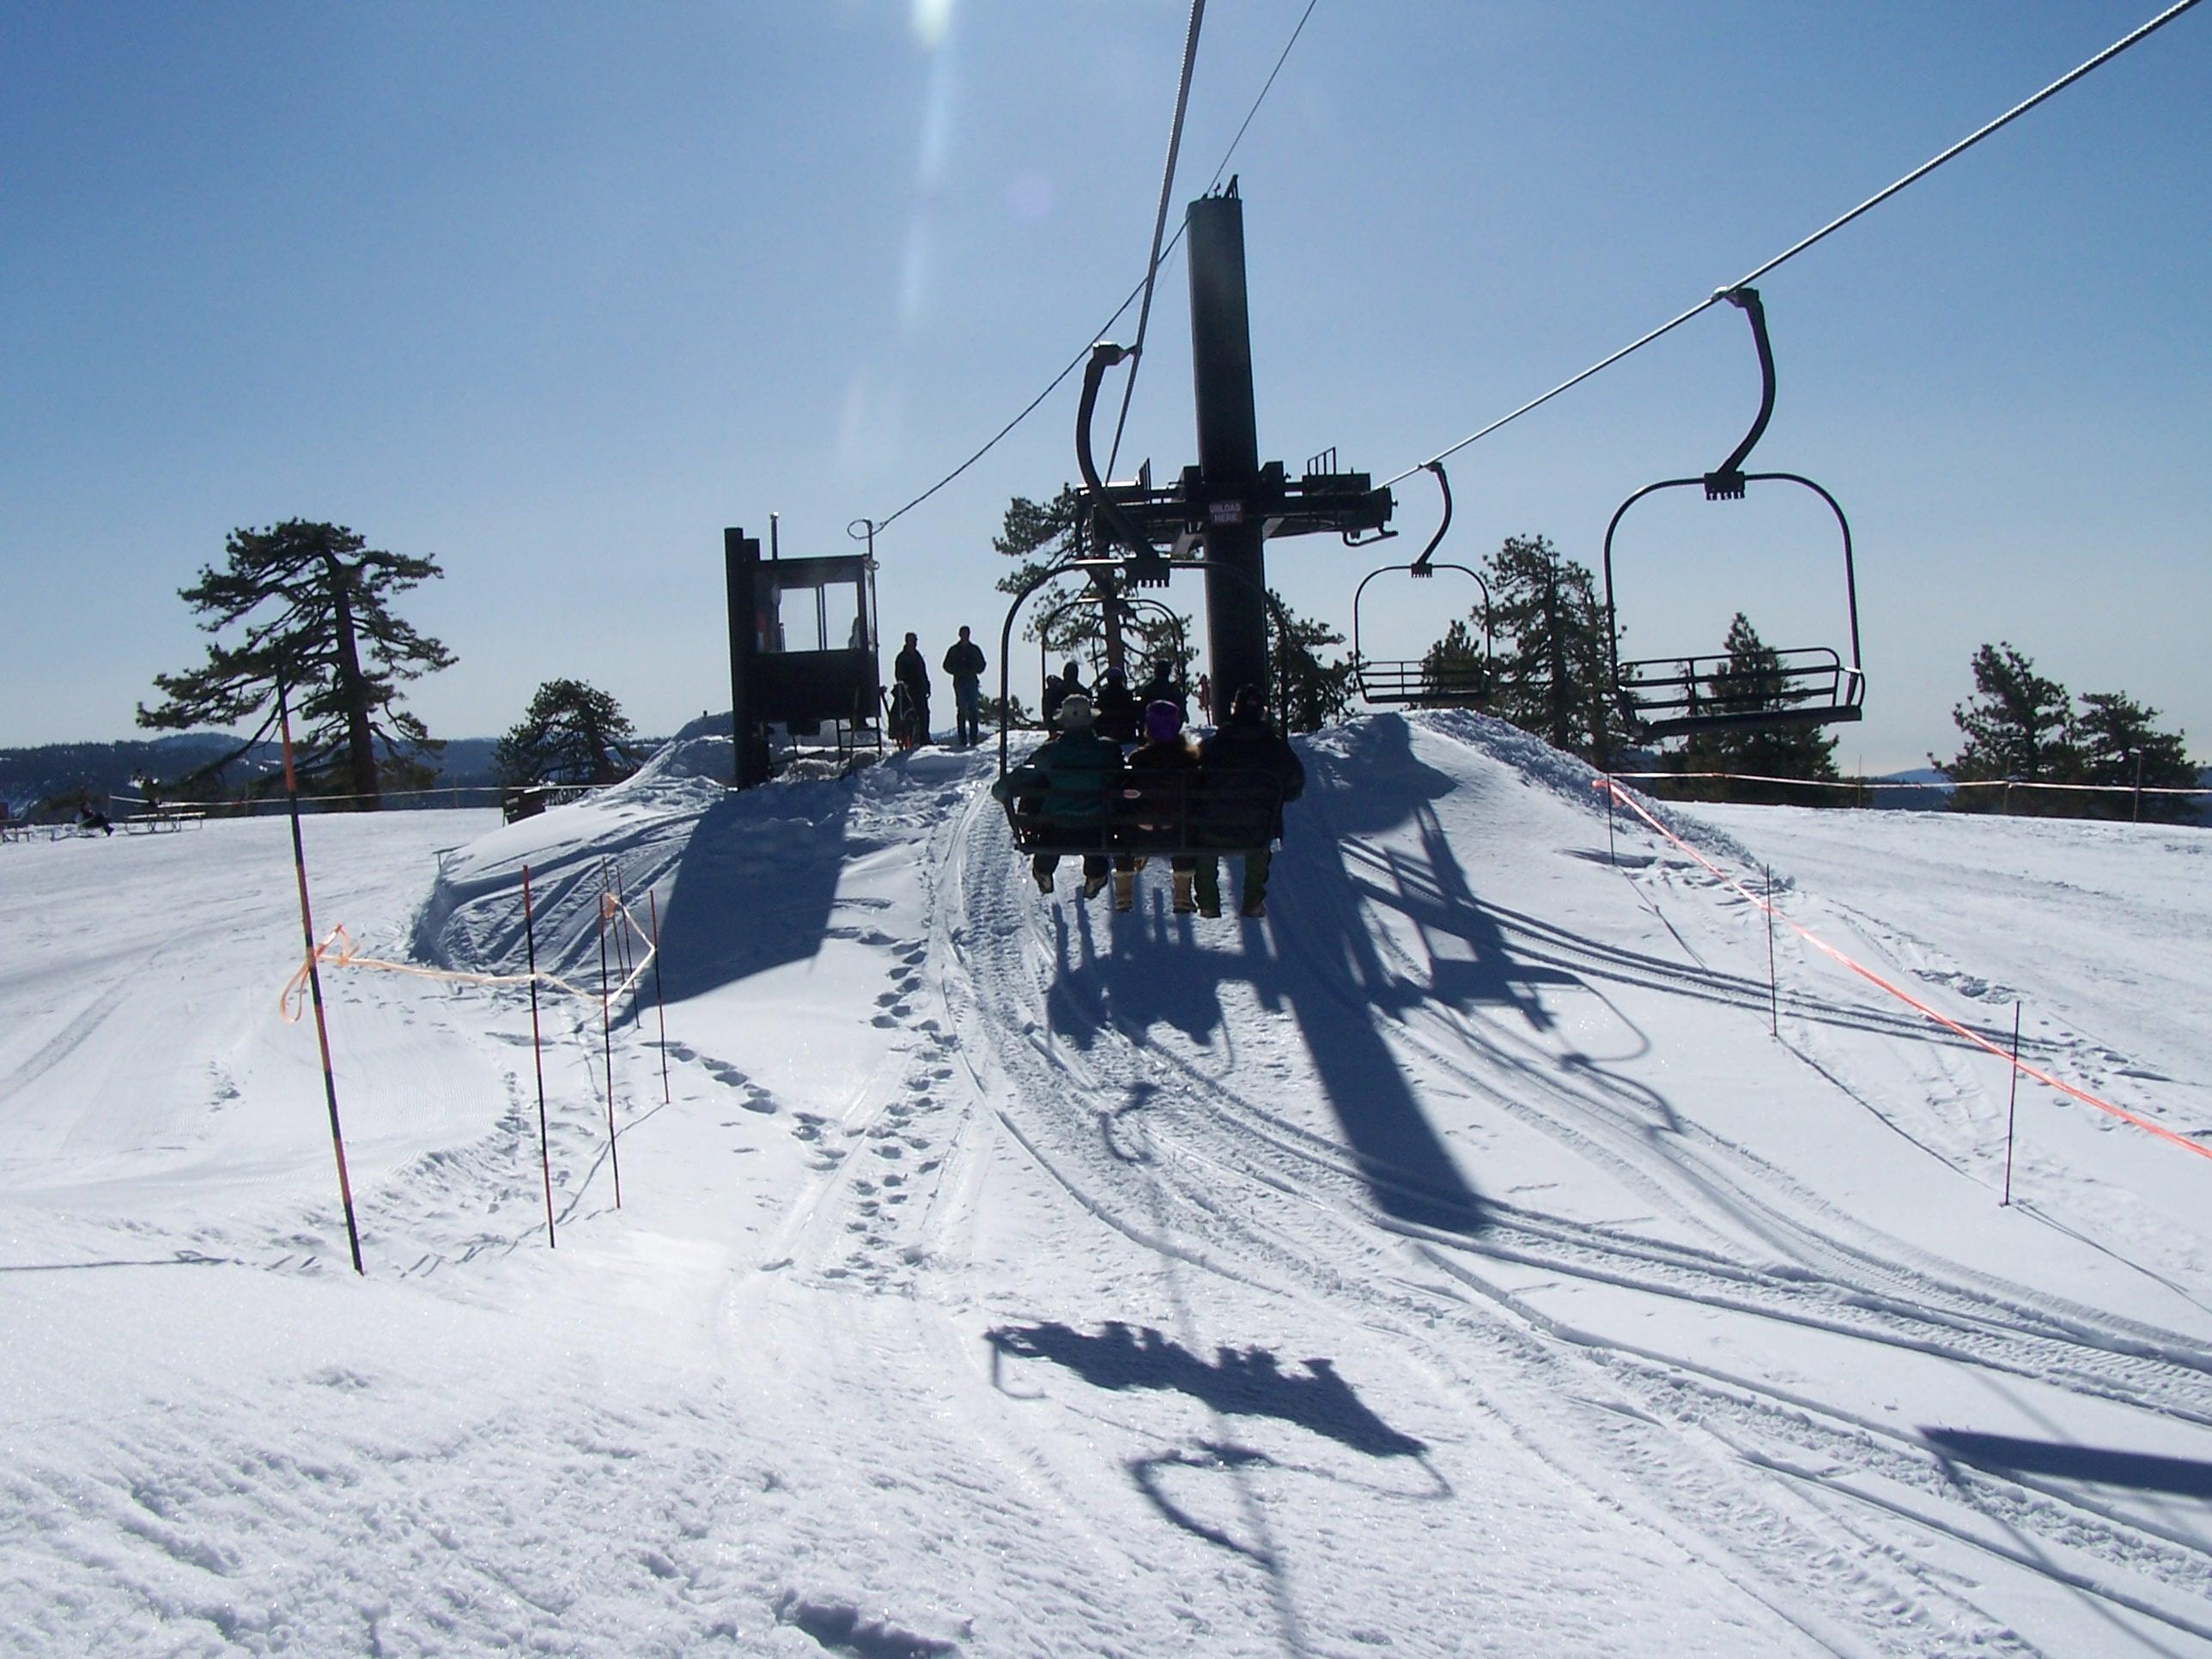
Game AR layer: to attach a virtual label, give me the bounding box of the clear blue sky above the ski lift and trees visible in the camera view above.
[0,0,2212,769]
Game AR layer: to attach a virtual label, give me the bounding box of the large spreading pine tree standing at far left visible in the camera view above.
[137,518,453,810]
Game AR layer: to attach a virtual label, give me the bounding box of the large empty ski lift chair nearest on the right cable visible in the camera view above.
[1606,288,1867,741]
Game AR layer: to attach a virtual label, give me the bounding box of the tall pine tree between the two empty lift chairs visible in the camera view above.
[1478,535,1626,765]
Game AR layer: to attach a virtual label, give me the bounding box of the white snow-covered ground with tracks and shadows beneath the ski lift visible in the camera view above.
[0,714,2212,1659]
